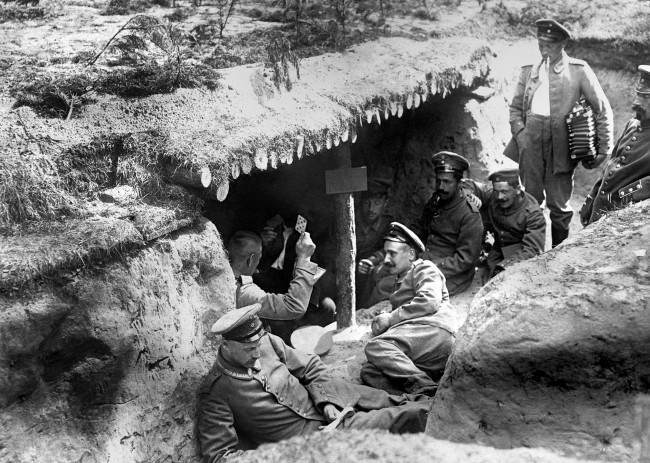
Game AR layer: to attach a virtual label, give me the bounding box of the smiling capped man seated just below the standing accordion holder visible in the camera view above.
[465,169,546,283]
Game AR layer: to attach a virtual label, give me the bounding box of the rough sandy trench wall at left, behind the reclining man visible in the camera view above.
[0,219,235,462]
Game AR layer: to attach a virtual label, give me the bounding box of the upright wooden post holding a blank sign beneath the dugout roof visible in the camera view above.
[334,142,357,329]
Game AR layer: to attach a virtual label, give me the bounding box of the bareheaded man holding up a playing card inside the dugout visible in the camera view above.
[228,231,330,336]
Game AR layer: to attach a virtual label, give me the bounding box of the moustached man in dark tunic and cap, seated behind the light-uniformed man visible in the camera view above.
[416,151,483,295]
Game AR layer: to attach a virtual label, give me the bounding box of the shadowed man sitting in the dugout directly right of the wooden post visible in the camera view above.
[355,178,395,308]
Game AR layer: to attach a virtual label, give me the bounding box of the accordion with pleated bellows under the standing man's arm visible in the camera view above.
[566,98,598,162]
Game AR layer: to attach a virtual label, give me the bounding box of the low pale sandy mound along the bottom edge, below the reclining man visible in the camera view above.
[228,429,604,463]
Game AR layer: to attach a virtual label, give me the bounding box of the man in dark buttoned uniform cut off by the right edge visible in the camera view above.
[580,64,650,226]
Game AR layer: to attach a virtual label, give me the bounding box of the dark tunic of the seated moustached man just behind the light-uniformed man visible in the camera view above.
[416,191,483,295]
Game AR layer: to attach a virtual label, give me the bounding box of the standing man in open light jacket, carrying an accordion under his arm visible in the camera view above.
[505,19,614,247]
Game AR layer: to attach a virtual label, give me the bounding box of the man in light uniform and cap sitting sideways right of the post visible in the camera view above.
[361,222,460,395]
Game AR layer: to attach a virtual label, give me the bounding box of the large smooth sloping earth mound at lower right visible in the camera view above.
[427,201,650,461]
